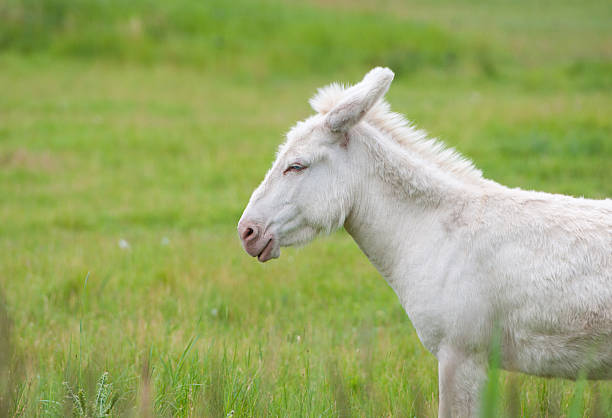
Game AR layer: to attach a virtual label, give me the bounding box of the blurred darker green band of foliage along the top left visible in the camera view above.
[0,0,461,74]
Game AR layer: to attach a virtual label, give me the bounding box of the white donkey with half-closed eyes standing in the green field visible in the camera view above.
[238,68,612,417]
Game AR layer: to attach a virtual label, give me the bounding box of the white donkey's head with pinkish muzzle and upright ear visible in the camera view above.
[238,67,393,262]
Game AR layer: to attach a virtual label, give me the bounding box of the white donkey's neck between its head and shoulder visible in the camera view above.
[344,127,478,290]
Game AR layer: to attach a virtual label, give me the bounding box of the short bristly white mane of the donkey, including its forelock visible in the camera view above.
[309,83,482,183]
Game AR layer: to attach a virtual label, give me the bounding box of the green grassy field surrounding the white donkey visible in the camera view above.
[0,0,612,417]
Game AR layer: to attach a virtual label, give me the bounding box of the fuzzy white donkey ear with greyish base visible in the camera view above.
[325,67,393,132]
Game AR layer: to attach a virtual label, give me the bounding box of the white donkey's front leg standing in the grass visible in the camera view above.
[438,349,487,418]
